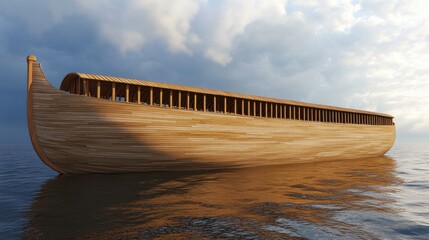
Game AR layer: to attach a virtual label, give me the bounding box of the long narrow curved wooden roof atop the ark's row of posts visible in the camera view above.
[61,73,393,118]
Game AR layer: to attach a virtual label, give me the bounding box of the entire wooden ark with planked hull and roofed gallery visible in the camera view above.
[27,56,395,173]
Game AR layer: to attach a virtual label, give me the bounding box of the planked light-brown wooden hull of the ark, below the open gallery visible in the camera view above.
[28,58,395,173]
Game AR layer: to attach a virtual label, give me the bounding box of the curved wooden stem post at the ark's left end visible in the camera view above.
[27,55,64,173]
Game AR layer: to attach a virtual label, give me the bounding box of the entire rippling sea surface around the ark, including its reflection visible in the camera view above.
[0,143,429,239]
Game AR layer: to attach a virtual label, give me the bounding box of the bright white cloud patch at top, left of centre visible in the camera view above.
[78,0,199,54]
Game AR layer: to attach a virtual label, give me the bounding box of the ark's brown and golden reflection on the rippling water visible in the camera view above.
[24,157,407,239]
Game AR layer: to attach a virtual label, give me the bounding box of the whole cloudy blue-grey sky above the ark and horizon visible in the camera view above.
[0,0,429,144]
